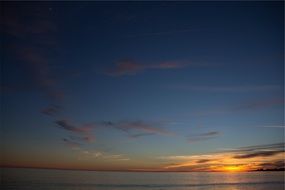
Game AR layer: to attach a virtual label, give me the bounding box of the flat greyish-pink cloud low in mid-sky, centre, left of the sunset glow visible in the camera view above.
[103,121,173,137]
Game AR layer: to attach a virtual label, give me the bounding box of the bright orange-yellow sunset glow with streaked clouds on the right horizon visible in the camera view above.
[161,152,285,172]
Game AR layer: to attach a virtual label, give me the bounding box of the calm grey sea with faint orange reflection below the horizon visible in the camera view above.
[1,168,284,190]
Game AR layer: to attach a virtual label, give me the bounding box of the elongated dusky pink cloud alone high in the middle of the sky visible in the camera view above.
[105,59,187,76]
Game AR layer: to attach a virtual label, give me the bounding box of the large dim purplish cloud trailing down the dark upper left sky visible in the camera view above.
[2,6,63,100]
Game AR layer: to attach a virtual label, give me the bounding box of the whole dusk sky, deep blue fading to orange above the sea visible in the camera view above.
[0,1,284,171]
